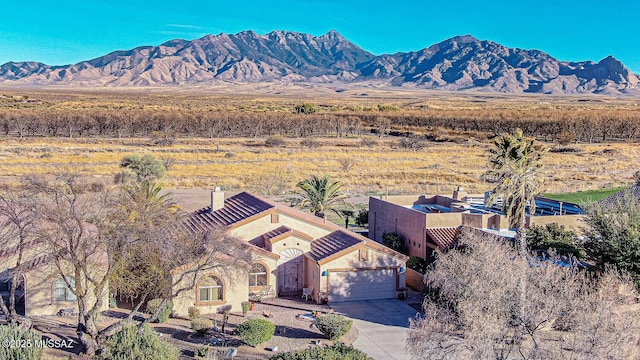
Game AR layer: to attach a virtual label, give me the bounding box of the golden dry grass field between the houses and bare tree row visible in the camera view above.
[0,137,640,194]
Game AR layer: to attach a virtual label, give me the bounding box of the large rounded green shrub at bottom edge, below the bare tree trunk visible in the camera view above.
[99,324,180,360]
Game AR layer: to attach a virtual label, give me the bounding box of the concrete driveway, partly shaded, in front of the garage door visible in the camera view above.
[331,299,416,360]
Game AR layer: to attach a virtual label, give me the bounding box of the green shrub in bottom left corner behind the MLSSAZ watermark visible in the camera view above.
[0,325,44,360]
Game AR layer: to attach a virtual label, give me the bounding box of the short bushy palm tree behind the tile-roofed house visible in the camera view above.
[297,175,350,218]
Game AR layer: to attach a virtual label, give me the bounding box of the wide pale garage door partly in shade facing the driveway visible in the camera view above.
[329,269,397,302]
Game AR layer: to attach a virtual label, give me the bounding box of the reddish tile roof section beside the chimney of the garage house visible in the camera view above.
[183,192,274,232]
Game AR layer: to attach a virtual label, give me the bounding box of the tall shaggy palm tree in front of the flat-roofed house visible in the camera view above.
[484,129,546,255]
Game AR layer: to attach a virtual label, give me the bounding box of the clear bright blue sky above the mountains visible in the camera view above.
[0,0,640,73]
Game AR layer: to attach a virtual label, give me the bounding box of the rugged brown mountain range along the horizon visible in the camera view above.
[0,31,640,95]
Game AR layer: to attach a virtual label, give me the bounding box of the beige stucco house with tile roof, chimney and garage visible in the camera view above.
[174,189,408,315]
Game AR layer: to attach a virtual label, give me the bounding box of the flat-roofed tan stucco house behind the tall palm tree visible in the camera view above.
[369,188,583,261]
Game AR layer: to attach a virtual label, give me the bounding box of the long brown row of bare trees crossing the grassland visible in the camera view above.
[0,109,640,143]
